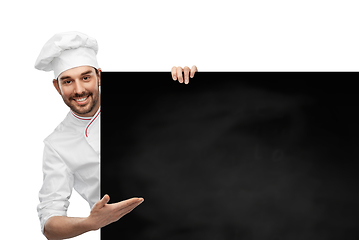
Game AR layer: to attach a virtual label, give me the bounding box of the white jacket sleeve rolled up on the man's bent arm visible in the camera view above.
[37,141,74,233]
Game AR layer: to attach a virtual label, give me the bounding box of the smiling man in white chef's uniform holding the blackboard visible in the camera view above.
[35,32,197,239]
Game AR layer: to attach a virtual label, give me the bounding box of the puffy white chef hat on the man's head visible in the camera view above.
[35,32,99,79]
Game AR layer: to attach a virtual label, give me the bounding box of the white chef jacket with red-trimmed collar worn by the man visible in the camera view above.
[37,109,101,232]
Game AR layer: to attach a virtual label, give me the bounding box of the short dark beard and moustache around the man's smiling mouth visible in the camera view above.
[62,91,99,115]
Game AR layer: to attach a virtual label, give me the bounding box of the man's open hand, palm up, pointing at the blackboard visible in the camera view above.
[86,194,144,230]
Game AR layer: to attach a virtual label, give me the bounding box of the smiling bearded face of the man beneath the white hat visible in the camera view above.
[53,66,101,117]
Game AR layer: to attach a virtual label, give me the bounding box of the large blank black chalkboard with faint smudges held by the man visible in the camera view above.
[101,72,359,240]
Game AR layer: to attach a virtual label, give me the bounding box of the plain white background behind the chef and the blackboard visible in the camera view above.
[0,0,359,239]
